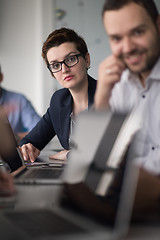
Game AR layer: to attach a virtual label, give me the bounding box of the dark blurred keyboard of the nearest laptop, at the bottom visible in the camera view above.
[5,209,85,237]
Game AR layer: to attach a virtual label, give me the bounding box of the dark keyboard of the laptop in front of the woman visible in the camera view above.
[25,168,62,179]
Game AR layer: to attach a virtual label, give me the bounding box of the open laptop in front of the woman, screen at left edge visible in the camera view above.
[0,107,65,184]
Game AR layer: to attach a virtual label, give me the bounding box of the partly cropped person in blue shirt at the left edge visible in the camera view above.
[0,66,40,140]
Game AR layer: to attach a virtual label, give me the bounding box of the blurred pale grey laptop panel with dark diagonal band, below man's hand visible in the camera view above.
[62,109,142,189]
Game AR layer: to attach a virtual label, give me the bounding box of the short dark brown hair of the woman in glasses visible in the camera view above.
[42,28,88,65]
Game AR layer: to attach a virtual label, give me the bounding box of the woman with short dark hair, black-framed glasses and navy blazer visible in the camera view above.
[20,28,96,162]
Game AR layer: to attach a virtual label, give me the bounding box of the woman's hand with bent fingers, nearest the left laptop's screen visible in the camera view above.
[20,143,40,162]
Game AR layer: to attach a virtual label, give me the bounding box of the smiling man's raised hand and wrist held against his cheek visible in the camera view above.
[95,55,125,110]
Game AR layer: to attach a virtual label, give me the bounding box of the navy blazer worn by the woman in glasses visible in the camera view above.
[19,75,97,150]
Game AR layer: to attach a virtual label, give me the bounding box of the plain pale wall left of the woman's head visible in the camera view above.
[0,0,54,114]
